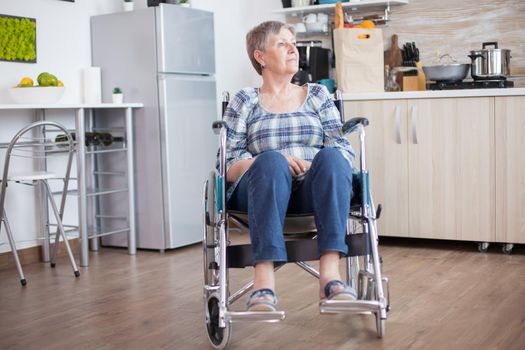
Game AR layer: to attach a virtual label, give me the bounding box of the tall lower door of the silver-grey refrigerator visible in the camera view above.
[159,74,218,249]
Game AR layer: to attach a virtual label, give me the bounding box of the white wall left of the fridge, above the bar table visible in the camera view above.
[0,0,122,103]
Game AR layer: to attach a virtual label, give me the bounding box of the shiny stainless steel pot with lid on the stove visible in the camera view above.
[468,41,511,80]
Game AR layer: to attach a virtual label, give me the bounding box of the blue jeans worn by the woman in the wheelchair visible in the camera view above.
[228,148,352,264]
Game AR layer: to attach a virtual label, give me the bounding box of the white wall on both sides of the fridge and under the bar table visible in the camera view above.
[0,0,284,253]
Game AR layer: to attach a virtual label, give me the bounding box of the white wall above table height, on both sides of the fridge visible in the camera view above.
[0,0,284,103]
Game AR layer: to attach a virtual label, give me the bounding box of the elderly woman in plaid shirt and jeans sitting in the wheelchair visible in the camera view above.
[224,21,355,311]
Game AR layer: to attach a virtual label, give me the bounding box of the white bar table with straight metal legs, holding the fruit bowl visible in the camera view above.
[0,103,143,266]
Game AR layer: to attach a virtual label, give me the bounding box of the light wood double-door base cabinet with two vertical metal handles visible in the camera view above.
[345,98,495,242]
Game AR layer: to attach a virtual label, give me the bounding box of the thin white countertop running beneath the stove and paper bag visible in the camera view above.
[343,88,525,101]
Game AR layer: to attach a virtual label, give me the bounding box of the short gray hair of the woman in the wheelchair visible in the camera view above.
[246,21,295,75]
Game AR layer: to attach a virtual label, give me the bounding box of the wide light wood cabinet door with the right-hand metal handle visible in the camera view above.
[407,97,495,242]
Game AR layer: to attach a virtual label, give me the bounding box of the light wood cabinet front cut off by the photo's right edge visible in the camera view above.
[495,96,525,243]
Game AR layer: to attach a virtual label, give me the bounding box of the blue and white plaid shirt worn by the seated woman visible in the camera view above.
[219,84,354,199]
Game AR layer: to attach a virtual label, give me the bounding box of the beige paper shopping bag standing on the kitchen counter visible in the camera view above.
[334,28,384,92]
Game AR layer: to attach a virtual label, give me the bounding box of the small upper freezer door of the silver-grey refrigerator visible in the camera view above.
[155,4,215,75]
